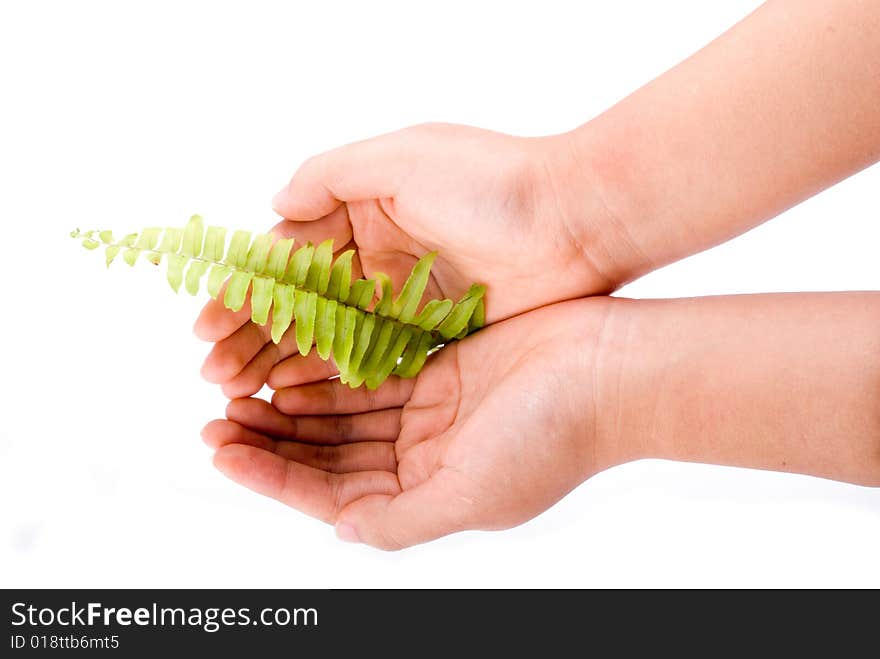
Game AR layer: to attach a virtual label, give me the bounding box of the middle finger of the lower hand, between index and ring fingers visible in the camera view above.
[202,419,397,474]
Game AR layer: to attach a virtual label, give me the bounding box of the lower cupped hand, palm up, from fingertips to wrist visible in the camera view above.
[203,298,616,549]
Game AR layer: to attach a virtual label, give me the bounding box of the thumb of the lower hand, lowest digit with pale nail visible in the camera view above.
[336,469,474,550]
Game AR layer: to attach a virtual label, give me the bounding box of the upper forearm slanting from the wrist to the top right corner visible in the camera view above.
[552,0,880,281]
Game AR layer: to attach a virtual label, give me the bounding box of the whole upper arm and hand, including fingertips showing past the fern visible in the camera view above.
[195,0,880,397]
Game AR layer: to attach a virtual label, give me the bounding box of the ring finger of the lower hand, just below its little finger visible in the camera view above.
[226,398,402,444]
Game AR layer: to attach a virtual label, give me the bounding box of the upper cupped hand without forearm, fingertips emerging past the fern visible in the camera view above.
[196,125,625,398]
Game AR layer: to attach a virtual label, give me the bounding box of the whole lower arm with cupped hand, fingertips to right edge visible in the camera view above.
[203,293,880,549]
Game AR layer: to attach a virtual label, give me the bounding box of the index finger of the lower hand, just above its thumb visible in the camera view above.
[214,444,400,523]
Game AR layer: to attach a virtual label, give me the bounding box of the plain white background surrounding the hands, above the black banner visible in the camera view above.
[0,0,880,587]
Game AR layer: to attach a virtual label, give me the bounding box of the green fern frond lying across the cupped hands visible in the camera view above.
[71,215,486,389]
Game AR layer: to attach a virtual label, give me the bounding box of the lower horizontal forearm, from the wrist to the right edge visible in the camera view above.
[597,293,880,486]
